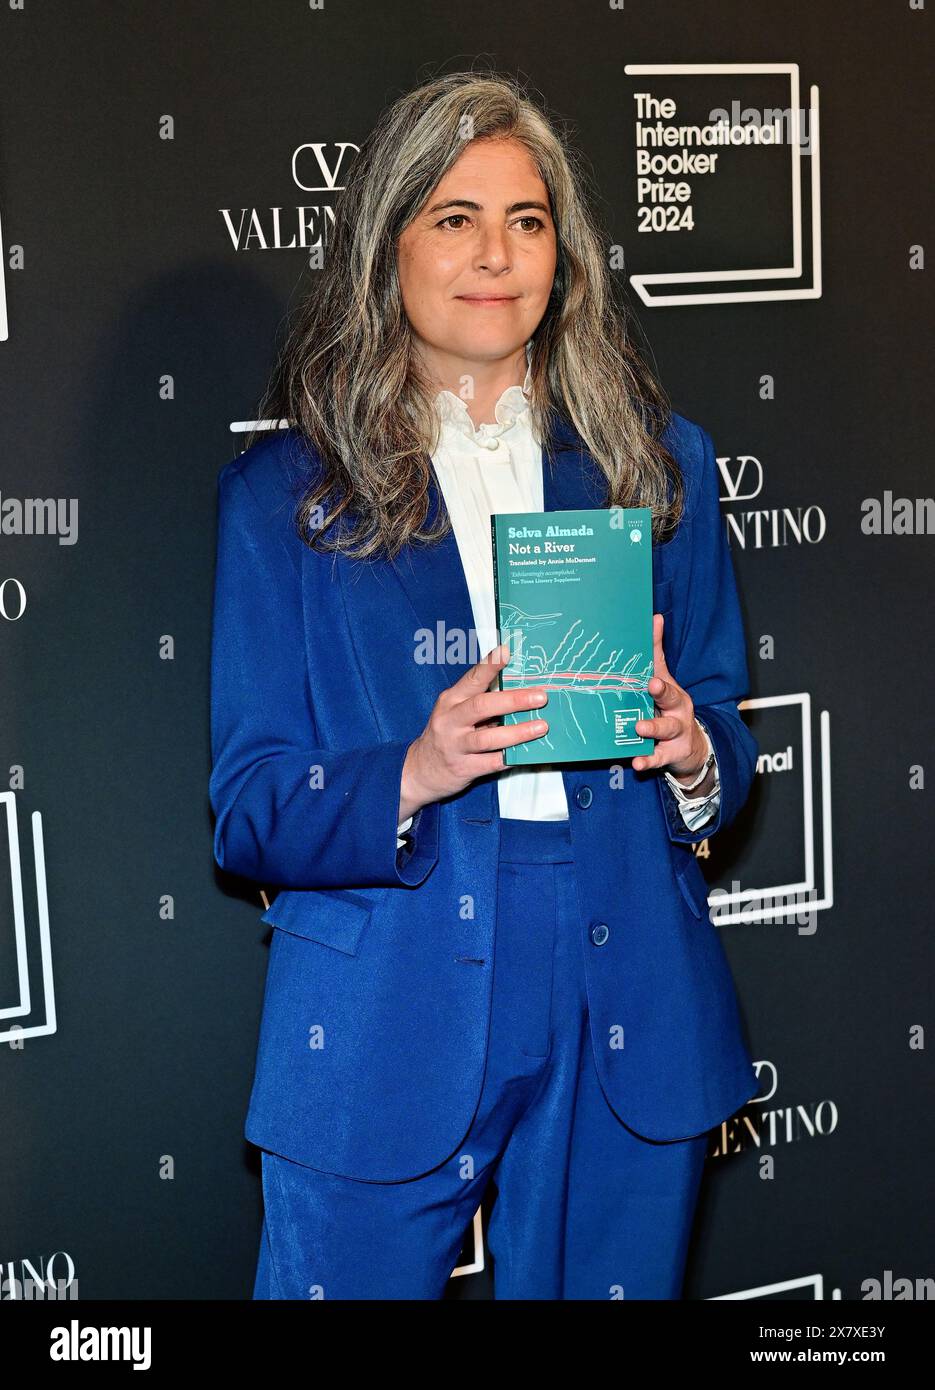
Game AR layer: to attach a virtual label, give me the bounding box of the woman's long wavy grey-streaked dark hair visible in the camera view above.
[247,72,684,559]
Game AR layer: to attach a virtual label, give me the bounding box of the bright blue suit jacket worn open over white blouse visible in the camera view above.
[210,414,757,1182]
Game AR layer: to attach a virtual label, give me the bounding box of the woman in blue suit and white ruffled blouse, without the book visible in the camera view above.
[210,74,757,1300]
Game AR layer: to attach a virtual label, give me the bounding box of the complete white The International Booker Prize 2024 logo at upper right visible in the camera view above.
[622,63,821,307]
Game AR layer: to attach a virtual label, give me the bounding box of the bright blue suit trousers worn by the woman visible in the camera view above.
[253,819,707,1300]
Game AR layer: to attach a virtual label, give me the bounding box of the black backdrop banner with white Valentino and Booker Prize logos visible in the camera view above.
[0,0,935,1301]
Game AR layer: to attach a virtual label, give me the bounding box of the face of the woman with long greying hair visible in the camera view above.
[397,140,556,372]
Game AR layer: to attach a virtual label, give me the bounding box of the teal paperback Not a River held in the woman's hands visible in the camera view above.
[490,507,656,766]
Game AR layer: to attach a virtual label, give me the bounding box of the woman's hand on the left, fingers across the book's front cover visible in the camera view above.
[399,644,549,821]
